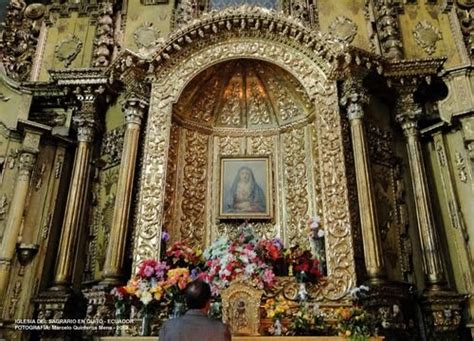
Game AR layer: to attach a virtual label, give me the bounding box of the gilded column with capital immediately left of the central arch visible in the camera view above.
[102,99,146,285]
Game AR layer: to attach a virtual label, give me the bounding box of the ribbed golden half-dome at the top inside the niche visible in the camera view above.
[175,59,312,129]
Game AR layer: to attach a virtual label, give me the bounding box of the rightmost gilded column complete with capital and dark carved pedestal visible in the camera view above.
[396,83,465,340]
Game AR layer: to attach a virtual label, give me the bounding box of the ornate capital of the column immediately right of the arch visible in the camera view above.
[341,77,369,120]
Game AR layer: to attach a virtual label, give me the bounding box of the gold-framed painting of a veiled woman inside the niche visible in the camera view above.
[218,156,273,219]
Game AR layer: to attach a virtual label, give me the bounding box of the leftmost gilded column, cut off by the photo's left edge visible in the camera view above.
[0,129,41,304]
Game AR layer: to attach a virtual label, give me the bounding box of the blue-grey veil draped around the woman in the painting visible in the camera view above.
[224,166,267,213]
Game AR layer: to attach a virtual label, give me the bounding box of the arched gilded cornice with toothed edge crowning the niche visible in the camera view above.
[107,6,384,83]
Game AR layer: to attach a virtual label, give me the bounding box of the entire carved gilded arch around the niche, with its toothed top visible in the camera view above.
[133,10,355,300]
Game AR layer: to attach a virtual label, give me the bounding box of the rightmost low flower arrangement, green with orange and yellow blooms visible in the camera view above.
[336,306,377,341]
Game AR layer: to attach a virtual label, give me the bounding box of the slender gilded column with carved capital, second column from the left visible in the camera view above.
[51,100,96,291]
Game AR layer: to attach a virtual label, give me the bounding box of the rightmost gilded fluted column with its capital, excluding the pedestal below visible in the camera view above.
[396,84,446,289]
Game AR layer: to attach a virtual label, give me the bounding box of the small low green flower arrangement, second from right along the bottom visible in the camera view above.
[289,302,327,335]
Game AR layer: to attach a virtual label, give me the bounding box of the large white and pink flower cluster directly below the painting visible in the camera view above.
[200,226,275,296]
